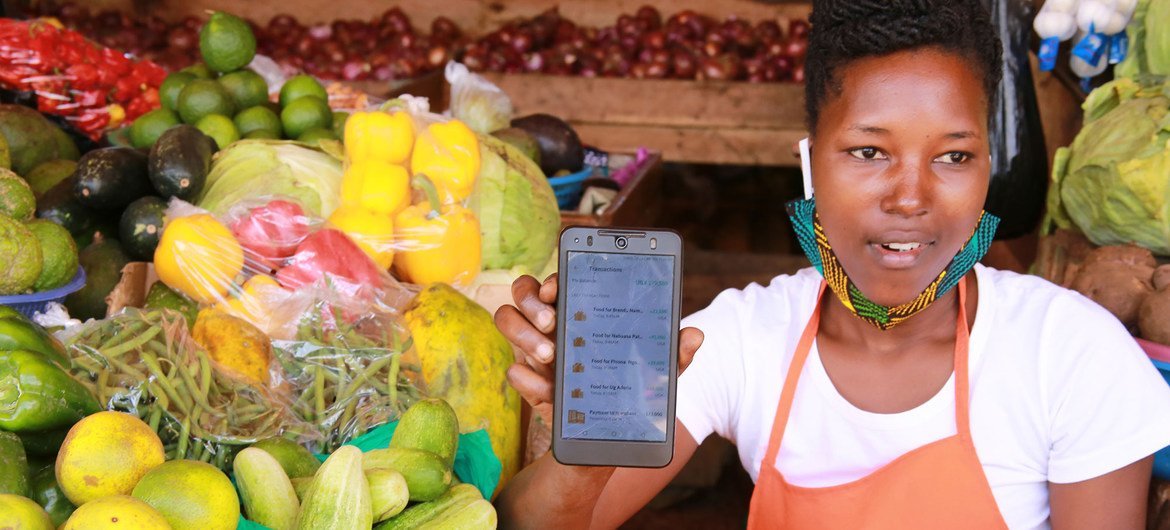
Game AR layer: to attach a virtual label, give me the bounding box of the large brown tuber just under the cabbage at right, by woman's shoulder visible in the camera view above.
[1073,245,1157,329]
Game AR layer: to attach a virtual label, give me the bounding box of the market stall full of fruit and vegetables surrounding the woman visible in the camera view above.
[0,0,1170,530]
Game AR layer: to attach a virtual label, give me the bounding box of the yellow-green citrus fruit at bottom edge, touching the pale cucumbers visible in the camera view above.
[131,460,240,530]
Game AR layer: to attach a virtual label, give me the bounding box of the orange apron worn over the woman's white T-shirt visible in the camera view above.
[748,281,1007,530]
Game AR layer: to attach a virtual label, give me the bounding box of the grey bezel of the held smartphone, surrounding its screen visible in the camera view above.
[552,226,682,468]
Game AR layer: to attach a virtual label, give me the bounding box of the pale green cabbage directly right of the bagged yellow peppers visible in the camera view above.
[469,135,560,274]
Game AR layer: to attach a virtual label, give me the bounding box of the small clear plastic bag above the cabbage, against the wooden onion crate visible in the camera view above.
[445,61,512,135]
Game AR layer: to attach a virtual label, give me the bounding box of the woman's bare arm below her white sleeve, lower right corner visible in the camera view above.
[1048,456,1154,530]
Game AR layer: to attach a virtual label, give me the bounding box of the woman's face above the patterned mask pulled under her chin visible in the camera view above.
[812,49,991,307]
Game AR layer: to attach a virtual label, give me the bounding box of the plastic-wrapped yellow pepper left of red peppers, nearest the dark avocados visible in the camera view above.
[154,214,243,304]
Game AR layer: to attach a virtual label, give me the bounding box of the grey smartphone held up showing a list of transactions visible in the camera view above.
[552,227,682,467]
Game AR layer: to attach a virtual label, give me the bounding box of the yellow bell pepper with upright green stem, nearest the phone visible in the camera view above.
[394,174,482,285]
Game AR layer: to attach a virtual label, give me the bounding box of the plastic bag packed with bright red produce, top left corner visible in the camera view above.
[0,19,166,140]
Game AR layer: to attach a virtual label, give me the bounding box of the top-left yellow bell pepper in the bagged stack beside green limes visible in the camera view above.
[344,111,414,164]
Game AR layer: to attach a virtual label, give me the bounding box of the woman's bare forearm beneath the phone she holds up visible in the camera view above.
[496,421,698,530]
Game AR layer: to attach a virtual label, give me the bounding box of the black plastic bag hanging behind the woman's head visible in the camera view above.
[983,0,1048,239]
